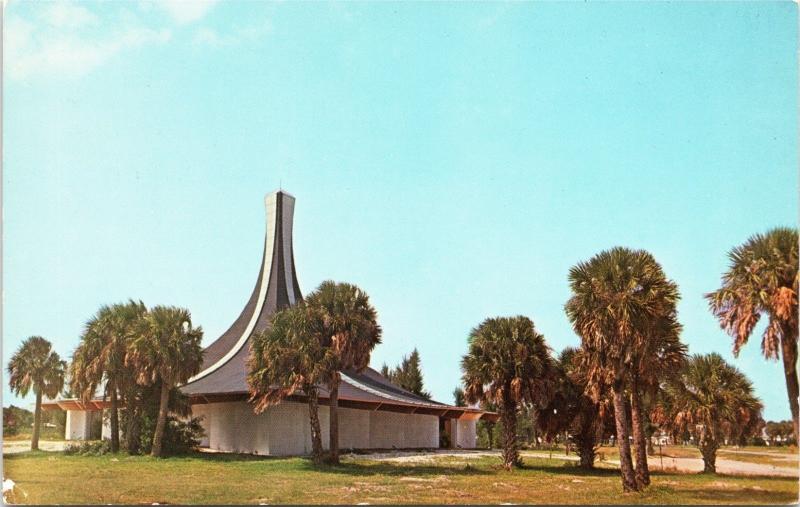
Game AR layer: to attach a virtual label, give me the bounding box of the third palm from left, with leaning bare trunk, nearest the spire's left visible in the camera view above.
[127,306,203,456]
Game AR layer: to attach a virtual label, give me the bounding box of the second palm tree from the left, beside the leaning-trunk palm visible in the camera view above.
[70,300,147,452]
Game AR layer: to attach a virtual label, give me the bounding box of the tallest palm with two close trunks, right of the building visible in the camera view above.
[565,247,679,491]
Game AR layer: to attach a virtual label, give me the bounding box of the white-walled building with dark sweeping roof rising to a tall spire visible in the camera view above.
[45,191,495,455]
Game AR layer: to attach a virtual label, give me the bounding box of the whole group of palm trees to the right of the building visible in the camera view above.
[454,228,798,491]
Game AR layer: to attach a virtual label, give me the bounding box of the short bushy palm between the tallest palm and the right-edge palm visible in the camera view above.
[659,353,762,473]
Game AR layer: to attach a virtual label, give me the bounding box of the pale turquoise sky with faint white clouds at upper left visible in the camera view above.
[2,0,798,420]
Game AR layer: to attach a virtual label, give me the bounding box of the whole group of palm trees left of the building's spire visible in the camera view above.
[8,300,203,456]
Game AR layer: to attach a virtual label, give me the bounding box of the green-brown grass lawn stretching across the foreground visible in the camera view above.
[4,452,798,504]
